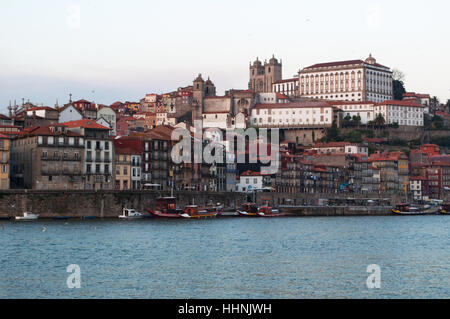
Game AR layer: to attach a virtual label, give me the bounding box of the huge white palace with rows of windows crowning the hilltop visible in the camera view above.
[298,55,393,102]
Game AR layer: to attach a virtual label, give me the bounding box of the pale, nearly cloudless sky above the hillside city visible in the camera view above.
[0,0,450,113]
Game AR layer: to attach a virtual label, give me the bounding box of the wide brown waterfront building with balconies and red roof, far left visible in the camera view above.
[11,124,84,189]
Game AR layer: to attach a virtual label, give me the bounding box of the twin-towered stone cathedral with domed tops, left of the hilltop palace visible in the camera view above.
[248,56,282,93]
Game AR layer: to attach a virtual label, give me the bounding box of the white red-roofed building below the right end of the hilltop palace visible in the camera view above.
[374,100,424,126]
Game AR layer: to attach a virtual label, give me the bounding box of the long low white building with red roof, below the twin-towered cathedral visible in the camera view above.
[250,102,334,128]
